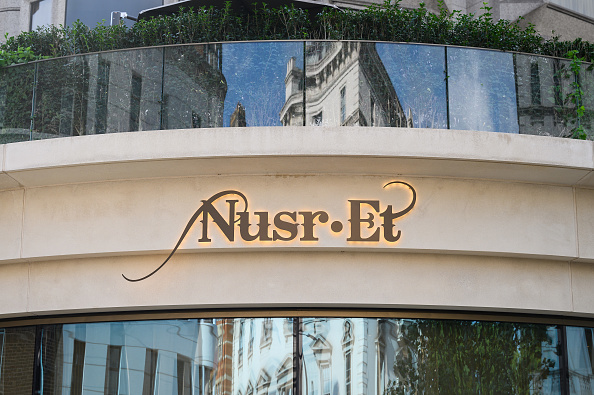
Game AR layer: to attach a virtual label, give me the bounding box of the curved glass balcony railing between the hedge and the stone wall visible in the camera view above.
[0,41,594,143]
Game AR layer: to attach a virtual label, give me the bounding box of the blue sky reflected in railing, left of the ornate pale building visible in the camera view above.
[223,42,303,126]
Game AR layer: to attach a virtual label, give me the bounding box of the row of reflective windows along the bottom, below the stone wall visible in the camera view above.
[0,318,564,395]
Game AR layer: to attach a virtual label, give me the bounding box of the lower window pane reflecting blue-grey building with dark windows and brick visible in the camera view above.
[38,318,293,395]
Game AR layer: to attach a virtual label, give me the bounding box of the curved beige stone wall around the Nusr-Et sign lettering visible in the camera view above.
[0,127,594,318]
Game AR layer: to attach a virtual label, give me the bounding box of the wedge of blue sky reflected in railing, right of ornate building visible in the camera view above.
[375,43,447,129]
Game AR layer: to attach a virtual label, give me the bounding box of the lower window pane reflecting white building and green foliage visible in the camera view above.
[302,318,561,395]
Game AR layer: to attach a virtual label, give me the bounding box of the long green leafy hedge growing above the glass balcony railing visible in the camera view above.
[0,0,594,61]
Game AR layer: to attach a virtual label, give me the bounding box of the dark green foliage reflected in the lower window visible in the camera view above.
[384,320,556,395]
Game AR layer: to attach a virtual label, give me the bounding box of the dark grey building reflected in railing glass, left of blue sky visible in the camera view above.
[33,44,227,138]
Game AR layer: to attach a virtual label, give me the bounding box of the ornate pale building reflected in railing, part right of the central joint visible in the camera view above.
[305,42,412,127]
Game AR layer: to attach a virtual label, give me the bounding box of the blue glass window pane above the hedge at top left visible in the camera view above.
[66,0,163,27]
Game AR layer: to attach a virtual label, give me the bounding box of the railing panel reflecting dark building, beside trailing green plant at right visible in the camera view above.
[515,54,575,137]
